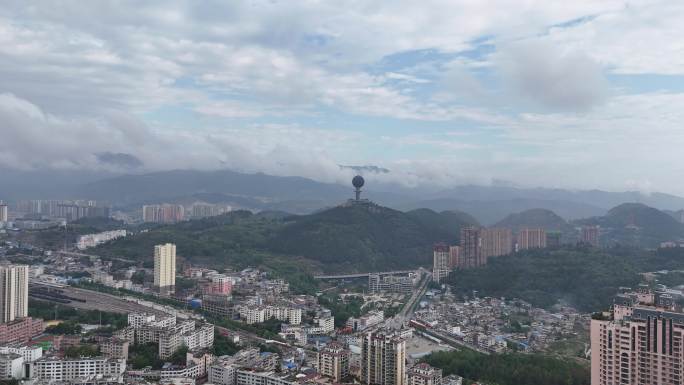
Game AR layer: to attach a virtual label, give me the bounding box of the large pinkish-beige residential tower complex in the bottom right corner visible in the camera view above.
[591,287,684,385]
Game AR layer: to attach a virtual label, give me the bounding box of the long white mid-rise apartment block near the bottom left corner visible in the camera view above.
[31,357,126,382]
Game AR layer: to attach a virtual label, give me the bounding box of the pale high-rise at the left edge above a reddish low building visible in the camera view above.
[0,265,29,323]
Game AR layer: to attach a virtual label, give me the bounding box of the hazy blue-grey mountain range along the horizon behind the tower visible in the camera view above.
[0,169,684,225]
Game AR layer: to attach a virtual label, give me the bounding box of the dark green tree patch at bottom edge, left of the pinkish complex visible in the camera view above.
[425,350,590,385]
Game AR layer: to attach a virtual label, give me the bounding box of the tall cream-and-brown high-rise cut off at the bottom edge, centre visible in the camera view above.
[361,332,406,385]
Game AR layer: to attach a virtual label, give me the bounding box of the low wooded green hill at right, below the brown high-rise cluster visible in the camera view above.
[450,248,684,312]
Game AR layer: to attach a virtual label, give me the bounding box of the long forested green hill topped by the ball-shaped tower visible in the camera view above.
[96,205,477,271]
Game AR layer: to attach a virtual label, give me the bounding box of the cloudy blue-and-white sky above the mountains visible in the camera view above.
[0,0,684,194]
